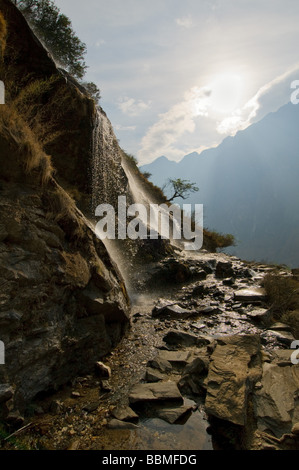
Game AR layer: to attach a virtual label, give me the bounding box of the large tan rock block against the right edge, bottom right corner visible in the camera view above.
[254,363,299,438]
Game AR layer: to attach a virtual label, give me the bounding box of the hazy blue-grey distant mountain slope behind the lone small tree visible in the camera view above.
[140,103,299,267]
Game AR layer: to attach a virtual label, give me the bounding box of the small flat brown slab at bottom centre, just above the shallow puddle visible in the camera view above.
[129,381,183,404]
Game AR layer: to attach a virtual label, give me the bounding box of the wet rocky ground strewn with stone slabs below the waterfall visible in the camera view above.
[2,252,299,450]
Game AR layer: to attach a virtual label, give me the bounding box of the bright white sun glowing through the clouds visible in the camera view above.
[210,74,243,114]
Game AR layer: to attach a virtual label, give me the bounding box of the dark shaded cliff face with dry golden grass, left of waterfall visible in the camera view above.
[0,0,129,417]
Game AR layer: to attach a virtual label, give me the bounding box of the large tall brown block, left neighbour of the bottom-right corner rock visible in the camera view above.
[205,335,261,426]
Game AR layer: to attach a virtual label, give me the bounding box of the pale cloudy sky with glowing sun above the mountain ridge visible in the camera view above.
[55,0,299,164]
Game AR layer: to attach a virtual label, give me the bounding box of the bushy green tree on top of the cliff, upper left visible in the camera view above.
[14,0,87,79]
